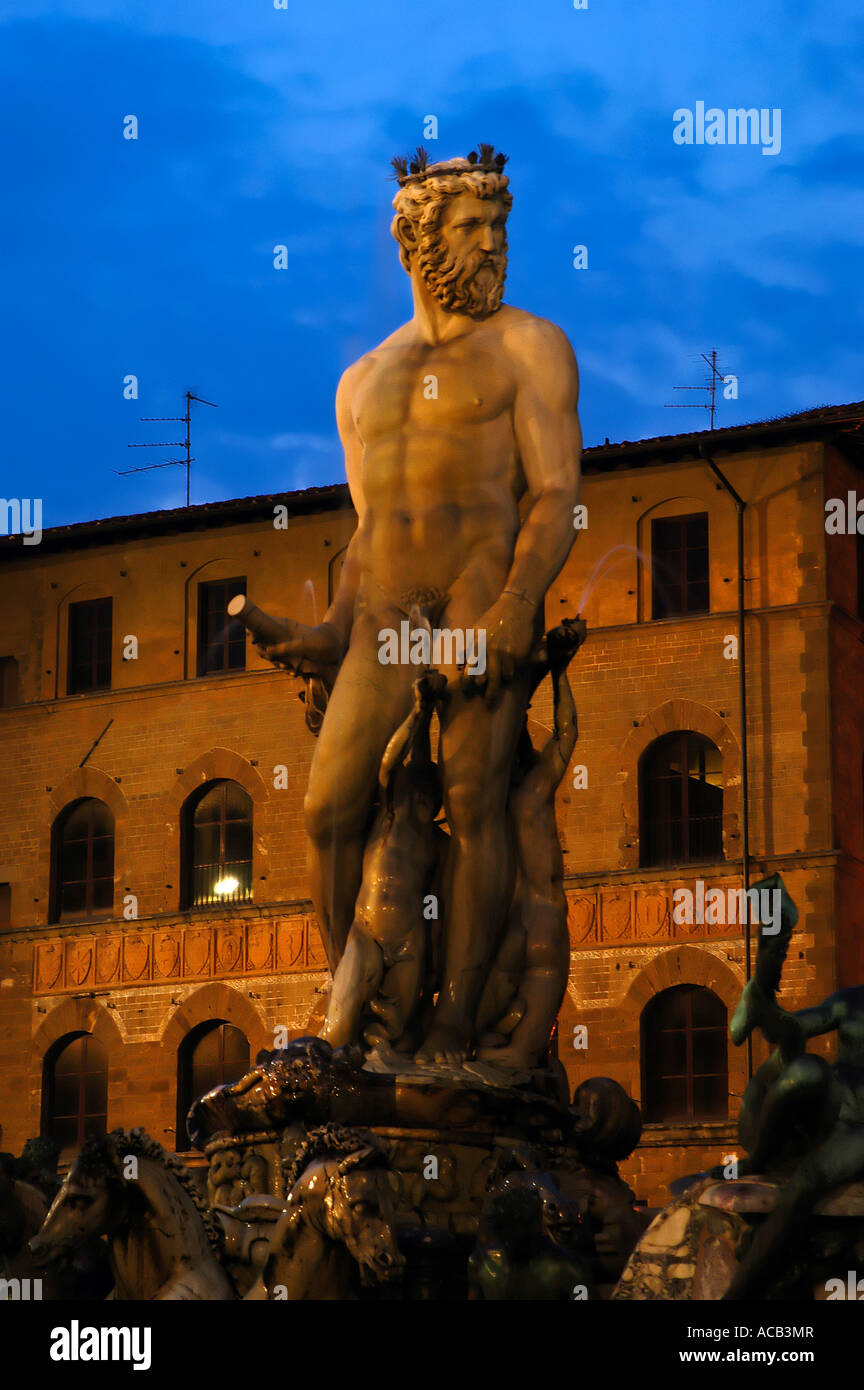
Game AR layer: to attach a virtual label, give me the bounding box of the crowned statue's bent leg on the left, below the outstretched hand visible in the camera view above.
[304,609,417,972]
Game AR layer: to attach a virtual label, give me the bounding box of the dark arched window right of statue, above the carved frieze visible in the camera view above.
[639,730,722,866]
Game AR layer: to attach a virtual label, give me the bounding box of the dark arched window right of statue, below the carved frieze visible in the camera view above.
[642,984,729,1125]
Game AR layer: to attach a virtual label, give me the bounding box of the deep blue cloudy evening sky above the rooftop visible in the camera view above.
[0,0,864,527]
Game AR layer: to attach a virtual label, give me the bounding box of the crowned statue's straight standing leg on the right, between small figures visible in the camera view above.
[417,667,528,1066]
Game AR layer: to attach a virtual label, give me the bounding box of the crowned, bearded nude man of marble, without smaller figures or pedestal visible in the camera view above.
[235,145,581,1065]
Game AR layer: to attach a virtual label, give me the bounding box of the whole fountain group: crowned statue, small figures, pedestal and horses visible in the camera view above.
[30,145,652,1301]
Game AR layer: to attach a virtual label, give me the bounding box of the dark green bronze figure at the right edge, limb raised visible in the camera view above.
[724,874,864,1301]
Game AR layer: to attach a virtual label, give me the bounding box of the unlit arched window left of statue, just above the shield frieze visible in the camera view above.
[51,796,114,922]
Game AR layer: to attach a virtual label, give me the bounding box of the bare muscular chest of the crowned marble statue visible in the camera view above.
[354,338,514,443]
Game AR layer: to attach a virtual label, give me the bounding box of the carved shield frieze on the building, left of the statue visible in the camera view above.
[33,916,326,994]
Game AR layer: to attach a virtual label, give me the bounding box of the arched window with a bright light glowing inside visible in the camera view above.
[182,781,251,908]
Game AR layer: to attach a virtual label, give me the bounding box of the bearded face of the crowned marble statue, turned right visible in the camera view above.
[417,193,507,318]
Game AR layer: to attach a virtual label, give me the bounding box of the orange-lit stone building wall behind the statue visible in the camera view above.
[0,417,864,1204]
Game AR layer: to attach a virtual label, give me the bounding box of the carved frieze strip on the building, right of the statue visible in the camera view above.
[567,878,743,949]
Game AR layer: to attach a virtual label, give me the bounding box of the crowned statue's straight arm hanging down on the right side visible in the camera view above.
[478,318,582,702]
